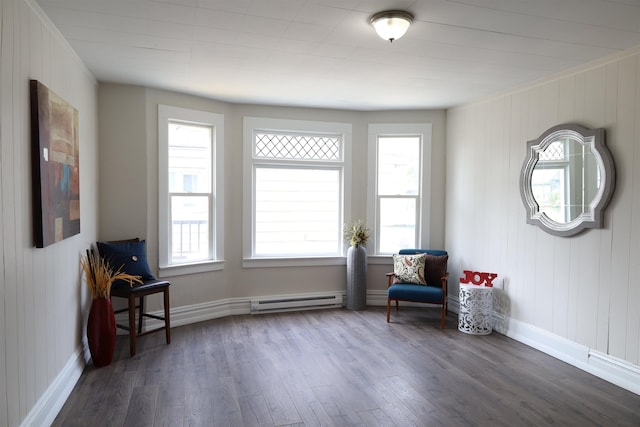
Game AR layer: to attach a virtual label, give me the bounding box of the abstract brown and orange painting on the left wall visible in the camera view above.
[30,80,80,248]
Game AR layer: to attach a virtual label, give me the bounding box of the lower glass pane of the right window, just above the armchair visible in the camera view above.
[379,198,417,254]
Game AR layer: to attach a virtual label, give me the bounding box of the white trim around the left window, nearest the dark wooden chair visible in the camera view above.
[158,105,224,277]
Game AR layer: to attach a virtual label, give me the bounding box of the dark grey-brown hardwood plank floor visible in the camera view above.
[53,307,640,427]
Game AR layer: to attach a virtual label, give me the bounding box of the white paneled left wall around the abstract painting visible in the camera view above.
[0,0,97,426]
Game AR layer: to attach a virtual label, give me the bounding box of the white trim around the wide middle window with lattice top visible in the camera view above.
[242,116,352,268]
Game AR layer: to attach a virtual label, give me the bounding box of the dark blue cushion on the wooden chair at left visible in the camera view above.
[98,240,155,285]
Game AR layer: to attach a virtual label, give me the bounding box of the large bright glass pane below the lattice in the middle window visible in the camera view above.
[255,167,342,256]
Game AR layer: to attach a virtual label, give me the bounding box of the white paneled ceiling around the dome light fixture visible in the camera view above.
[37,0,640,110]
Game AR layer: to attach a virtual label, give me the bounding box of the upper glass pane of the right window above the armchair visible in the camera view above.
[378,136,420,196]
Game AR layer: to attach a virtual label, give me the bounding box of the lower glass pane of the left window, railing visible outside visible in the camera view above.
[171,196,209,262]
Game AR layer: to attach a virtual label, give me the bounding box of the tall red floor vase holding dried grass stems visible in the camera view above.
[87,298,116,367]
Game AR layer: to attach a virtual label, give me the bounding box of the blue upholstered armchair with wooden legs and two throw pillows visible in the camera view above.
[387,249,449,329]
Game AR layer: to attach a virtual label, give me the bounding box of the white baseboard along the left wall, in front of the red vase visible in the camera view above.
[20,348,85,427]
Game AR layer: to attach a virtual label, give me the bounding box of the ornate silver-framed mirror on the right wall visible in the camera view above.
[520,124,616,236]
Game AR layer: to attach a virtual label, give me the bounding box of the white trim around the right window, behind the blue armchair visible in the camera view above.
[367,123,433,264]
